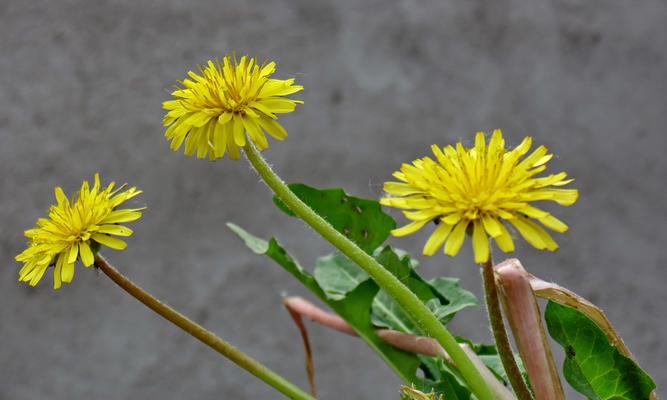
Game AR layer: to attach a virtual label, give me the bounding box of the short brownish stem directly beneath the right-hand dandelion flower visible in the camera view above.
[482,256,533,400]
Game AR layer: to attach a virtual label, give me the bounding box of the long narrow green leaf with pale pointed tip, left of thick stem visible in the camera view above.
[227,223,421,384]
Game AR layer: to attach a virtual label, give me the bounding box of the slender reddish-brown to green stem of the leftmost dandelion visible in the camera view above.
[95,254,315,400]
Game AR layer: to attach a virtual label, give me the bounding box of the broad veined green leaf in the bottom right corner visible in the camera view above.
[544,301,655,400]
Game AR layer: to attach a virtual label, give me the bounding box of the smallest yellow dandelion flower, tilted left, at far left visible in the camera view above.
[16,174,145,289]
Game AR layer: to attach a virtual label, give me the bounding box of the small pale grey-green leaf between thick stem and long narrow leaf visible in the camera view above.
[313,252,368,300]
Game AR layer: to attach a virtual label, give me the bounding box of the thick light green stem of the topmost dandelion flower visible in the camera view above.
[244,141,494,400]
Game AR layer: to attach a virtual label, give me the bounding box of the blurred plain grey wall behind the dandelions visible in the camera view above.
[0,0,667,400]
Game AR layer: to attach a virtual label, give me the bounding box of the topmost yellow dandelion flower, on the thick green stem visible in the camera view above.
[162,56,303,160]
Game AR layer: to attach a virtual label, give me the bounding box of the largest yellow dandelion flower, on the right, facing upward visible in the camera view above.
[380,130,579,263]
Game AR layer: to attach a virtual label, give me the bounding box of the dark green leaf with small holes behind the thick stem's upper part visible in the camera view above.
[273,183,396,254]
